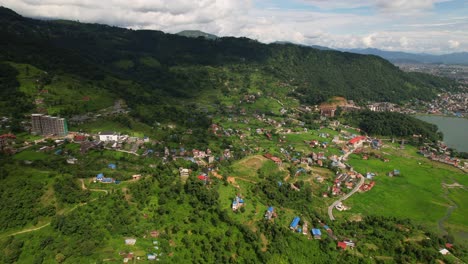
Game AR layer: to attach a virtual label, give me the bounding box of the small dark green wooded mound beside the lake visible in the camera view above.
[345,110,442,142]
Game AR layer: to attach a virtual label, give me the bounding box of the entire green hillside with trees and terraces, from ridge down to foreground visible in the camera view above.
[0,7,468,264]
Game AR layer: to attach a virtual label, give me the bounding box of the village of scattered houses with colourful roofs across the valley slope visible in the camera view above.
[0,92,468,263]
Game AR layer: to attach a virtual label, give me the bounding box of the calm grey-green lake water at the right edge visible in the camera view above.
[415,115,468,152]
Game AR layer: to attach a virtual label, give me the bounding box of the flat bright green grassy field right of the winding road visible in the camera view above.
[336,145,468,241]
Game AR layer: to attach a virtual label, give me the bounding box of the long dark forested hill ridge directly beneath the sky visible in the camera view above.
[0,8,456,118]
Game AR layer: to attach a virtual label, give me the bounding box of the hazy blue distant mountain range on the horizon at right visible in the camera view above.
[341,48,468,65]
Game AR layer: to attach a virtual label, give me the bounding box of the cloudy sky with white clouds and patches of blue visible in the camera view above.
[0,0,468,54]
